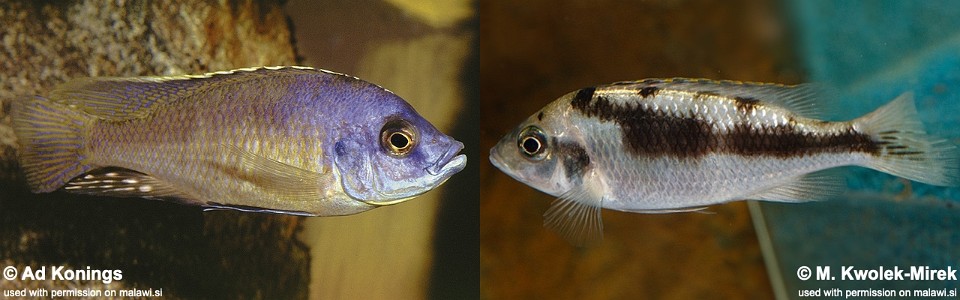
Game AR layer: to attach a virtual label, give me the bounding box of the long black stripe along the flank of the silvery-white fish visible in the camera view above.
[571,91,879,158]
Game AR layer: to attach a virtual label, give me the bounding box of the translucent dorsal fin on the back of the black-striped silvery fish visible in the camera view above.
[606,78,826,119]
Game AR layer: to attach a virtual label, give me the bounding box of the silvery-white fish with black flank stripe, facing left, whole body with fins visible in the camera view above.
[490,79,958,244]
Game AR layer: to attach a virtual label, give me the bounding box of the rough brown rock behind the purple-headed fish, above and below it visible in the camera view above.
[0,1,309,298]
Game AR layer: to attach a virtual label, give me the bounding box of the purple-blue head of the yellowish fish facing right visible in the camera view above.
[334,90,467,206]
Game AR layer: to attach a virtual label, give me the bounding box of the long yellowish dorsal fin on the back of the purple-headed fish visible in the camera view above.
[50,67,332,120]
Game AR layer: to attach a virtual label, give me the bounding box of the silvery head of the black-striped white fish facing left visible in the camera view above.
[490,98,586,197]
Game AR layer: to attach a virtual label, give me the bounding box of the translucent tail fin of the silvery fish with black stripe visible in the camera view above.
[854,93,960,186]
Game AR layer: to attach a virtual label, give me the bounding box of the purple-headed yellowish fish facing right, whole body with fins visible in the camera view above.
[12,67,466,216]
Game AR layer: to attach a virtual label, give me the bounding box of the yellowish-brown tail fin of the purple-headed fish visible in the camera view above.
[11,96,94,193]
